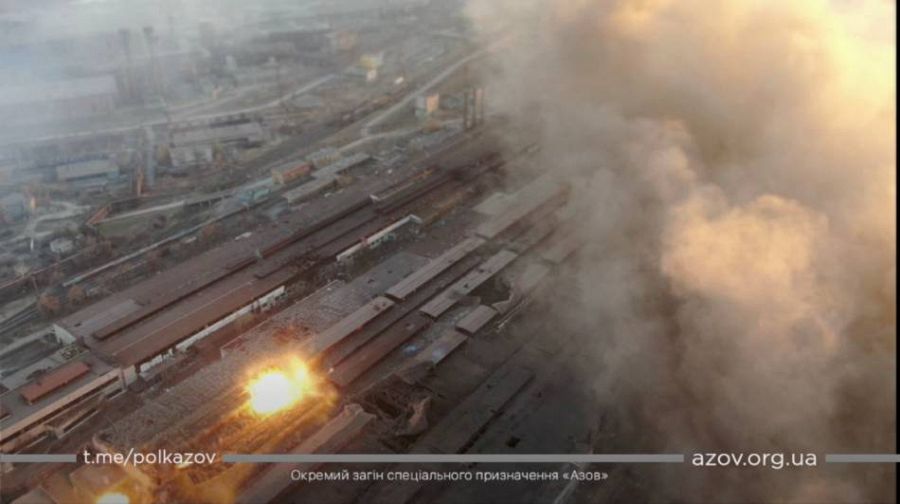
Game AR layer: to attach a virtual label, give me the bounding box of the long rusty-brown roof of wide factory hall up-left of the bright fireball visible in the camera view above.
[57,187,367,365]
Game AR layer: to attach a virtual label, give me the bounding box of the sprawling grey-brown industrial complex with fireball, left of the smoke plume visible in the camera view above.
[0,2,596,503]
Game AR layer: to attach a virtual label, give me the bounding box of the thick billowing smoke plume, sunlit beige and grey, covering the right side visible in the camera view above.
[468,0,896,502]
